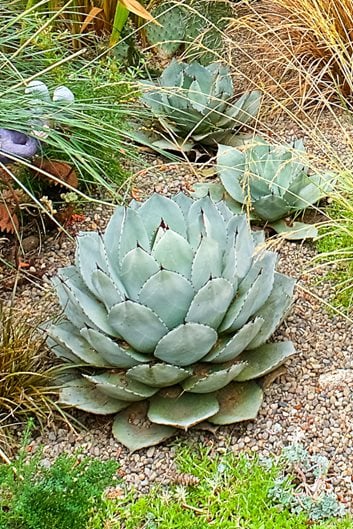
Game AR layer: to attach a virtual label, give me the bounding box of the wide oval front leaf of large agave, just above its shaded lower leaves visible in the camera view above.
[154,323,217,367]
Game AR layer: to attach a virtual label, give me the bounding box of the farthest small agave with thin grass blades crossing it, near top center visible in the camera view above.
[137,60,261,152]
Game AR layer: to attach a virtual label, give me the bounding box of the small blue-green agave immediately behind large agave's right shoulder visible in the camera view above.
[194,137,334,240]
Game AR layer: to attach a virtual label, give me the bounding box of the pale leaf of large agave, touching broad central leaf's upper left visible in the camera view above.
[121,248,160,301]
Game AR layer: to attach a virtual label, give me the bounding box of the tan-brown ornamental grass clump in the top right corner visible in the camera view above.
[233,0,353,107]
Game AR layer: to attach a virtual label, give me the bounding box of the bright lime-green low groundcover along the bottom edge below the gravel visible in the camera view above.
[88,444,352,529]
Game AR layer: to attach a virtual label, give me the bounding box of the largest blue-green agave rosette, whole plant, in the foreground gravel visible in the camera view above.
[47,193,295,450]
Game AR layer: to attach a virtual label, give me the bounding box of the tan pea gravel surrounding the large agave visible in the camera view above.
[0,161,353,507]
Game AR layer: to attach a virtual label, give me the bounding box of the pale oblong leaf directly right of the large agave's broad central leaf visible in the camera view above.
[185,278,235,329]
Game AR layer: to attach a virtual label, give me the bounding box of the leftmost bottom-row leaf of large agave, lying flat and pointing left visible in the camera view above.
[59,378,129,415]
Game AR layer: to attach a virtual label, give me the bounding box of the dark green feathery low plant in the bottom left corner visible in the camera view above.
[0,434,118,529]
